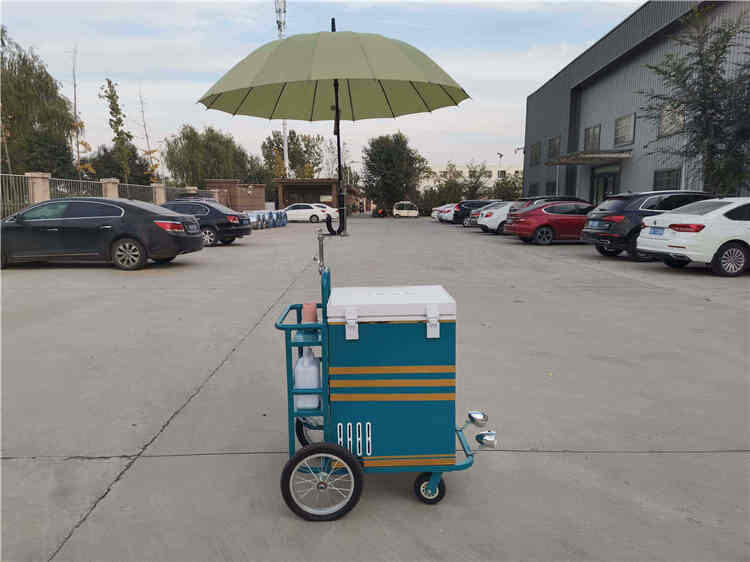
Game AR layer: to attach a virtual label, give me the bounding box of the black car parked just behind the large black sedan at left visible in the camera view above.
[162,198,253,246]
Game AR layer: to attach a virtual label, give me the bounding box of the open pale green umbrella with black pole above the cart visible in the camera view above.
[198,20,469,233]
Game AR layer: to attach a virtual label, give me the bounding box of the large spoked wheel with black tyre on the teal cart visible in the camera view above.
[281,443,364,521]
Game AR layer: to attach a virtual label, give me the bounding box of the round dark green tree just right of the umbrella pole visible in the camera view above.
[362,132,430,209]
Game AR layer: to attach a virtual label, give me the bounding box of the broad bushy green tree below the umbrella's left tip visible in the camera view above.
[163,125,250,187]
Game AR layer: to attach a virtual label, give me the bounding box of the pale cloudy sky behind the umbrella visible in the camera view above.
[1,0,640,175]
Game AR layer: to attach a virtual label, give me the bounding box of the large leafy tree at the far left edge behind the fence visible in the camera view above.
[0,26,76,177]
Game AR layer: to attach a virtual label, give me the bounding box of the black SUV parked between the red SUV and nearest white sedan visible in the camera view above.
[581,190,713,260]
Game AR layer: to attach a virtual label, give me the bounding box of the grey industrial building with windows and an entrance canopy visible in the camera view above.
[524,1,750,202]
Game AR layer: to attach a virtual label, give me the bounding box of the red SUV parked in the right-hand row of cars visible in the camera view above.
[505,201,594,245]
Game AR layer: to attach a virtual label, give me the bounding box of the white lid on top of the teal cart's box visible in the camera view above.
[328,285,456,321]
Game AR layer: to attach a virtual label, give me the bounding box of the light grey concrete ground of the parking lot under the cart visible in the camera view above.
[2,219,750,562]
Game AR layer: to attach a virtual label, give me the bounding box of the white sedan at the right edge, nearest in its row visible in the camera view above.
[638,197,750,277]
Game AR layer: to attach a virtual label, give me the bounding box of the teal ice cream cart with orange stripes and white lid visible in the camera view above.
[276,233,496,521]
